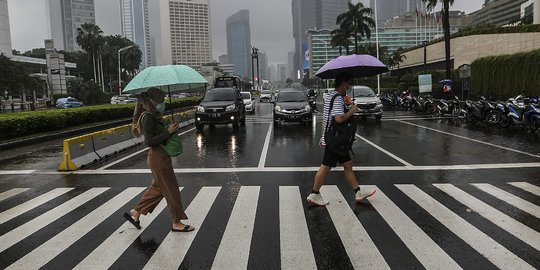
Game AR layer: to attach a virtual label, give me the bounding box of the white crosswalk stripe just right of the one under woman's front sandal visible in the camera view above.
[212,186,260,270]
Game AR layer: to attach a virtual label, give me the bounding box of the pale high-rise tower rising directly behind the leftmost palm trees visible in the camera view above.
[48,0,96,52]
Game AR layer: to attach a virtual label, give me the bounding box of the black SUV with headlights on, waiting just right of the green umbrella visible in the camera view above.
[195,88,246,131]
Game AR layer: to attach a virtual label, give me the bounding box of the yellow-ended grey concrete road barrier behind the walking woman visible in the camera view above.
[58,111,195,171]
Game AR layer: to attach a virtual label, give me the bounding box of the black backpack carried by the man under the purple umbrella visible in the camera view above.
[324,94,356,156]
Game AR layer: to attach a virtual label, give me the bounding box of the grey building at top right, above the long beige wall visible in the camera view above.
[471,0,527,26]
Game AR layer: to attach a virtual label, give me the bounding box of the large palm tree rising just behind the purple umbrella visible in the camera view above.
[336,2,375,53]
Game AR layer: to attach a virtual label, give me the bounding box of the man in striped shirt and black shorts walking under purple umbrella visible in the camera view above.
[307,73,376,206]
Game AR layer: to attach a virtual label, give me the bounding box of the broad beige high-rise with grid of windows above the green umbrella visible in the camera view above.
[155,0,212,68]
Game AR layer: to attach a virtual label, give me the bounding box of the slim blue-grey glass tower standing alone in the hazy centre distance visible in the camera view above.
[226,9,251,78]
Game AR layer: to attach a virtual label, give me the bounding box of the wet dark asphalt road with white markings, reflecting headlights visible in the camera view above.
[0,99,540,269]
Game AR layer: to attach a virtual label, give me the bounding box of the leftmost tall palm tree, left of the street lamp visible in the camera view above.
[77,23,104,82]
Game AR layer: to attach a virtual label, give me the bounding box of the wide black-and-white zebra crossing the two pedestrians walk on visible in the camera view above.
[0,182,540,269]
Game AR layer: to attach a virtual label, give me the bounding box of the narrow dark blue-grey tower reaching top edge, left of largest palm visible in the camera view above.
[294,0,316,79]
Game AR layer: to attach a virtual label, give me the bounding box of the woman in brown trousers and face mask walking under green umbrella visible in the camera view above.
[124,88,195,232]
